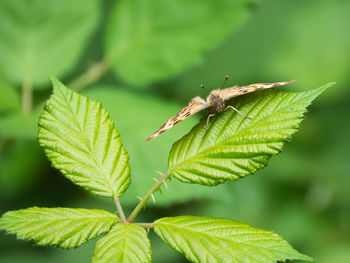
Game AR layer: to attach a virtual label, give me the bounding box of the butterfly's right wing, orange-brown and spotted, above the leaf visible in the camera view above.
[220,80,295,100]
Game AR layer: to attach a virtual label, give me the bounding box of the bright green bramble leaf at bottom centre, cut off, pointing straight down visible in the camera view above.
[93,224,151,263]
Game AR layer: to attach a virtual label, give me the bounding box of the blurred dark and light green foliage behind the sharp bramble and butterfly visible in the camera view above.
[0,0,350,263]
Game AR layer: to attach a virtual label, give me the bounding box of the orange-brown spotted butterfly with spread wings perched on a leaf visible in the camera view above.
[144,76,295,142]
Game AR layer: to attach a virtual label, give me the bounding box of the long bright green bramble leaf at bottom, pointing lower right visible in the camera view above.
[154,216,313,263]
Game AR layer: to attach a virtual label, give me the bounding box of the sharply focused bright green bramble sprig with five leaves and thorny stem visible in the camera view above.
[0,77,332,263]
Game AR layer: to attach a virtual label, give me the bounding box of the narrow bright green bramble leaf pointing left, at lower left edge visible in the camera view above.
[0,207,117,248]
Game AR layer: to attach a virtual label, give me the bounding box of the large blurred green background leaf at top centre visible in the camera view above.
[105,0,252,86]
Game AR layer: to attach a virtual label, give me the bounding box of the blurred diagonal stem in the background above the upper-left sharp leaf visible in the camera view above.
[68,59,111,91]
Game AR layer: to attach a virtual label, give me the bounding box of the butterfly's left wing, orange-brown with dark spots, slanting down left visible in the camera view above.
[144,97,209,142]
